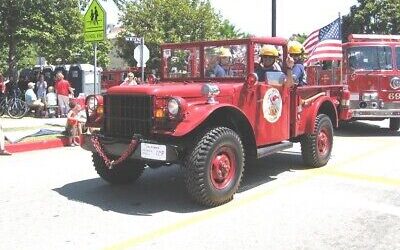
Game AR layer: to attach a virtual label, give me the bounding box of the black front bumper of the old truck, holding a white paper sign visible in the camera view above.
[81,134,179,163]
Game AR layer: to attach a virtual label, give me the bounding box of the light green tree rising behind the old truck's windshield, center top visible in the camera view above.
[116,0,245,72]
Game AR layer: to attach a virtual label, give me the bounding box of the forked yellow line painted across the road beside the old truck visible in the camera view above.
[105,142,400,250]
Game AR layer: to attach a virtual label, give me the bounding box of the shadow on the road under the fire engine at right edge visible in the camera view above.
[335,122,400,137]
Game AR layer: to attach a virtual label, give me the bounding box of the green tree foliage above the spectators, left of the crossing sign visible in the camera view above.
[0,0,110,77]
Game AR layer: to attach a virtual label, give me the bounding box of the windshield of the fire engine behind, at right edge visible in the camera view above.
[347,46,393,70]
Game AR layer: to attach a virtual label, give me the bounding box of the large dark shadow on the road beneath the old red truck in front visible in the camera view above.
[54,152,304,216]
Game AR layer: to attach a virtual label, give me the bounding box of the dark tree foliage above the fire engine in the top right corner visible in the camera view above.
[343,0,400,40]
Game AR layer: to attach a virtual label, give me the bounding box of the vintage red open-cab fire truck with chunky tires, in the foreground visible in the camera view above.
[81,37,350,206]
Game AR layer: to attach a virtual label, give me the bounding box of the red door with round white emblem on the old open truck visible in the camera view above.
[256,72,290,145]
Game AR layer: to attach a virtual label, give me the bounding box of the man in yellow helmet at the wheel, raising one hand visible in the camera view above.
[255,45,294,86]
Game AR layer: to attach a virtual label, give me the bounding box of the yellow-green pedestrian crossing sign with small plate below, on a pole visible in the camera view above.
[83,0,107,42]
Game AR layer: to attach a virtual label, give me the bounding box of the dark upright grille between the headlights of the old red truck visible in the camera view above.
[104,95,153,138]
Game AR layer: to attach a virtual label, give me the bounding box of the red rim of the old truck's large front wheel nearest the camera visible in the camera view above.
[210,147,236,189]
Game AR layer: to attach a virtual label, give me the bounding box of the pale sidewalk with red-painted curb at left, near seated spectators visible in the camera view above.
[0,116,68,153]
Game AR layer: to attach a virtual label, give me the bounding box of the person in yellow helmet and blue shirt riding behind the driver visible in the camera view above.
[288,41,307,86]
